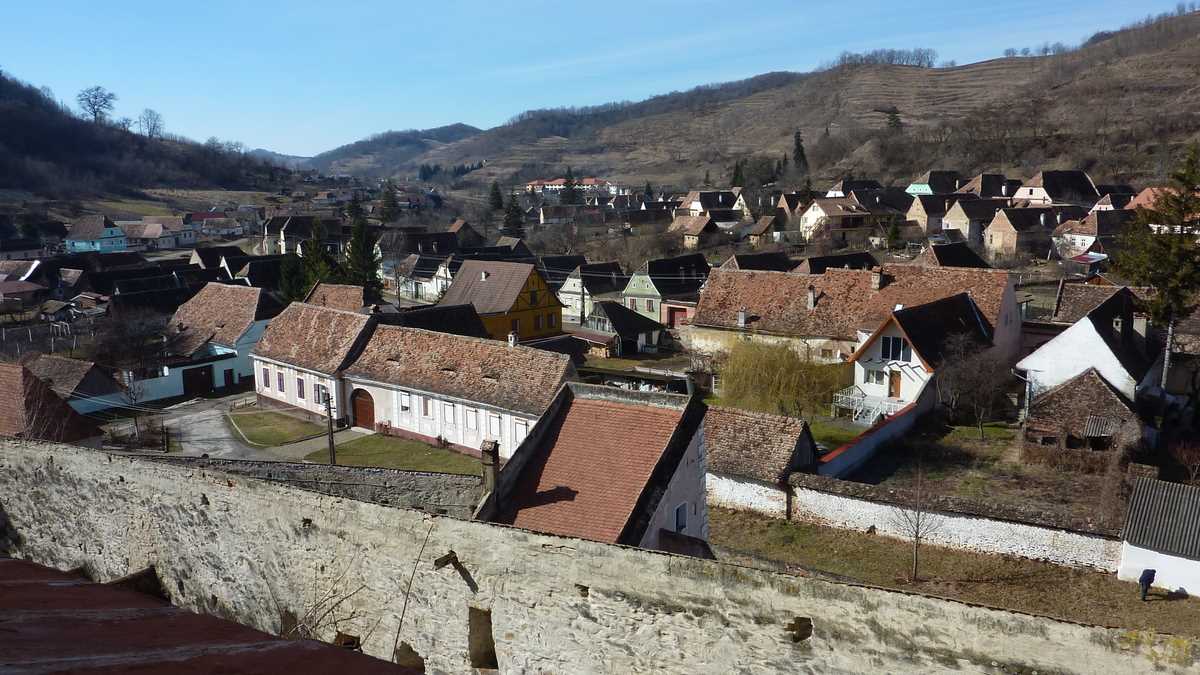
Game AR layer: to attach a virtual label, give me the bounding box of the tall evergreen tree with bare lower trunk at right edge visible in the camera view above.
[1116,145,1200,388]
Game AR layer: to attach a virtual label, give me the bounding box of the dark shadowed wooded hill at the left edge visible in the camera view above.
[0,72,286,197]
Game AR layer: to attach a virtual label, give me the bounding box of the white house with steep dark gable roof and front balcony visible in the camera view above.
[833,292,991,425]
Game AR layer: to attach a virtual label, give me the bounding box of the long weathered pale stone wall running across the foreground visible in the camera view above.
[0,441,1200,673]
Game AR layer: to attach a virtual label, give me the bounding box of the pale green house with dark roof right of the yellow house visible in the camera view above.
[622,253,709,328]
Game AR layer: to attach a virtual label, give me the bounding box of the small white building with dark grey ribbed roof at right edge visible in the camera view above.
[1117,478,1200,595]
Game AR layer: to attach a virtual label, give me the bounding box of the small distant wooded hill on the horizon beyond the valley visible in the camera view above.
[300,124,480,177]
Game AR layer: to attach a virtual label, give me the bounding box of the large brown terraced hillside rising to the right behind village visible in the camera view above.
[326,13,1200,187]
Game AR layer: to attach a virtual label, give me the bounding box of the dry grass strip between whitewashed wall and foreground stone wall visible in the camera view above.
[709,508,1200,635]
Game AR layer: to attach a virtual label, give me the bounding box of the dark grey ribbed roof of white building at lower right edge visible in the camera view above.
[1123,478,1200,561]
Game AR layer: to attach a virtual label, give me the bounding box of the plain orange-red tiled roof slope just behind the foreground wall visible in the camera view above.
[499,386,685,544]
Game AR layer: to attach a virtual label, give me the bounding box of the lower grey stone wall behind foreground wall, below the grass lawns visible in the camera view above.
[139,454,482,518]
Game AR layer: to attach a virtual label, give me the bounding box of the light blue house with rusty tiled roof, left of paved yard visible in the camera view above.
[132,282,280,402]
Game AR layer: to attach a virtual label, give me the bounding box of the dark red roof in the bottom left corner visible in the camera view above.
[0,558,413,675]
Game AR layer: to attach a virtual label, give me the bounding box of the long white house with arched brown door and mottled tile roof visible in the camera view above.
[343,325,575,459]
